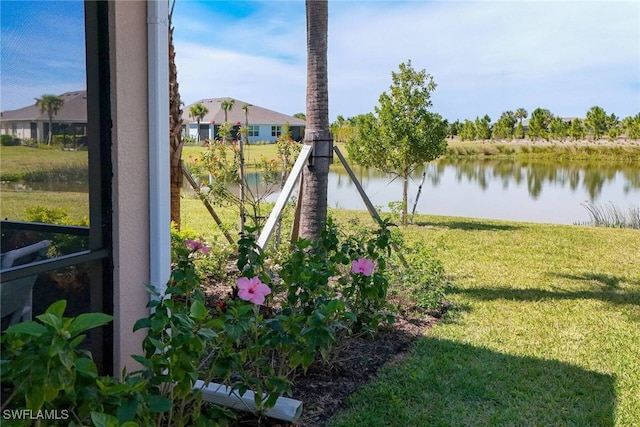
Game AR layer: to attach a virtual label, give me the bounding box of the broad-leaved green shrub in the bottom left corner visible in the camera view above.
[0,300,112,426]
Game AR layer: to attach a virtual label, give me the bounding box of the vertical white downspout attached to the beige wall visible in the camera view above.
[147,0,171,294]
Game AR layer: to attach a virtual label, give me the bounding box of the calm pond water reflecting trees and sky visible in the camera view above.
[3,158,640,224]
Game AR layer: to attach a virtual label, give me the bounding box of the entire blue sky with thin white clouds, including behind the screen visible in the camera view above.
[0,0,640,121]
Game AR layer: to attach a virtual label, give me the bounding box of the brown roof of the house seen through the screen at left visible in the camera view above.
[0,90,87,122]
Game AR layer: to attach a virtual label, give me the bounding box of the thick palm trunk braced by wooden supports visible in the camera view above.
[300,0,333,240]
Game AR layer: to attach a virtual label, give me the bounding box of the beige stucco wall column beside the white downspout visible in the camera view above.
[109,1,149,375]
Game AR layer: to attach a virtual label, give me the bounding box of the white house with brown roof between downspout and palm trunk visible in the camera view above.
[182,98,305,142]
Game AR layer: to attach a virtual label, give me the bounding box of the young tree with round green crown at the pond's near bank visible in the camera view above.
[347,60,447,224]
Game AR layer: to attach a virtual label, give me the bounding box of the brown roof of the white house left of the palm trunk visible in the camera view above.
[182,98,305,126]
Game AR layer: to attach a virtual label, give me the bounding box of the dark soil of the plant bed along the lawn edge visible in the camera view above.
[207,280,449,427]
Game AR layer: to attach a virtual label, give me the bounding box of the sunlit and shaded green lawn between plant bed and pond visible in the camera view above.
[331,216,640,427]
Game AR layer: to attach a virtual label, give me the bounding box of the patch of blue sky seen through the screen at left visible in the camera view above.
[0,0,86,111]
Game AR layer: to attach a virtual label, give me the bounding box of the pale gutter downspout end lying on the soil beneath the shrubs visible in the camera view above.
[193,380,302,422]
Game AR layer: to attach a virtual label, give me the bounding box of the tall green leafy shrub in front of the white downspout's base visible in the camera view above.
[130,239,230,426]
